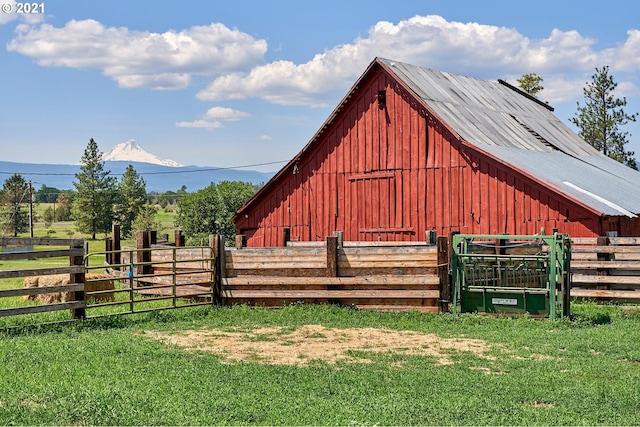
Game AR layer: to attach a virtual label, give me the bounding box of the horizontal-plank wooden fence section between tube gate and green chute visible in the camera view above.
[220,237,441,312]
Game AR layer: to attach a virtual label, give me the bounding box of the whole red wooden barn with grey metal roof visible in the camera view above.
[235,58,640,246]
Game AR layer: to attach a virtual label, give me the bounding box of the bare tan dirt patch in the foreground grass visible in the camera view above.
[144,325,502,366]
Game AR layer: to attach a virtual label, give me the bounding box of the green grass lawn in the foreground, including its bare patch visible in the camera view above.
[0,304,640,425]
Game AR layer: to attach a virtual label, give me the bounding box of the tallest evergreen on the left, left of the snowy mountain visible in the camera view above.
[72,138,115,239]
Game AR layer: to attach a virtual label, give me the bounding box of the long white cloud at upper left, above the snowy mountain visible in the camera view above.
[7,19,267,89]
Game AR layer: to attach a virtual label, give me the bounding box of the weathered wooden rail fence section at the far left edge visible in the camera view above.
[0,237,85,318]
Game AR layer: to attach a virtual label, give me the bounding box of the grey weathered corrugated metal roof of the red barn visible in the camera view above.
[378,58,640,217]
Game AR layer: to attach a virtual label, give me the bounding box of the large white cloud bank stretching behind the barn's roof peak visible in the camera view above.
[197,15,640,107]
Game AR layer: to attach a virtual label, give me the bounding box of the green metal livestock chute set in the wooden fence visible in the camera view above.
[451,233,571,319]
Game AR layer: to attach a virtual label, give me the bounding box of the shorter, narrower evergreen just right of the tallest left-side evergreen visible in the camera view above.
[114,165,147,237]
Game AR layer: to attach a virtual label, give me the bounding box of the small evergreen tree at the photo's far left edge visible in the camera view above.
[0,173,29,237]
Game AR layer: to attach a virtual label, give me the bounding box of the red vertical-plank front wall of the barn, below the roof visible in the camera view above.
[236,67,602,247]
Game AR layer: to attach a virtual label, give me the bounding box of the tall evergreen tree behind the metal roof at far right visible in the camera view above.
[571,66,638,169]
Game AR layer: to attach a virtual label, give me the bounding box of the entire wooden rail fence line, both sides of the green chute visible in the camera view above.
[0,235,640,326]
